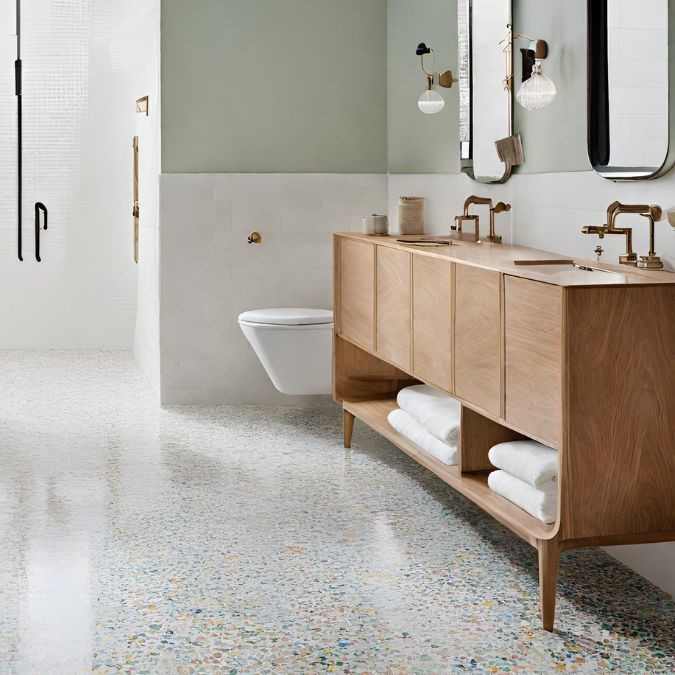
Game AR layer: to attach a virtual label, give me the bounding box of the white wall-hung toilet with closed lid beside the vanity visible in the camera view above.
[239,308,333,395]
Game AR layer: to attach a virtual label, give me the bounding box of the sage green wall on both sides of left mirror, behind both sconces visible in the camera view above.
[388,0,590,173]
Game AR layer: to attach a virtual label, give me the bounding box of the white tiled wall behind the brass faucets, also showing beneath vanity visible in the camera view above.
[389,172,675,595]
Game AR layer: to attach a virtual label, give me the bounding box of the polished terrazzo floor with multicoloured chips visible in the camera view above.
[0,352,675,674]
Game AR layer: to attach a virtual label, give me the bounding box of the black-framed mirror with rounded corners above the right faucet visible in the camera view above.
[587,0,675,181]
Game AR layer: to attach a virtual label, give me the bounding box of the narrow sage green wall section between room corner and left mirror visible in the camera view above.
[387,0,459,173]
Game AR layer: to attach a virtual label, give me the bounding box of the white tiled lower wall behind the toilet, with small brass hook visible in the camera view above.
[160,174,387,405]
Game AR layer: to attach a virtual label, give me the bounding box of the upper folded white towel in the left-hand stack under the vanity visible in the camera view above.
[396,384,462,444]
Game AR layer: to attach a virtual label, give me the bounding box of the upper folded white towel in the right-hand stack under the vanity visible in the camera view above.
[488,441,558,489]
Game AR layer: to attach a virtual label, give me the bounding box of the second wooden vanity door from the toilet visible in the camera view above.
[376,246,412,371]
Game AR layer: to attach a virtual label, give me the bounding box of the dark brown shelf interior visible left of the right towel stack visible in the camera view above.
[458,406,524,473]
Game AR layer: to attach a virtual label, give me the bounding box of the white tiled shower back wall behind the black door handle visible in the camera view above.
[0,0,146,349]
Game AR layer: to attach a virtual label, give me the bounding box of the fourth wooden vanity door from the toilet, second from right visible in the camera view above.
[455,264,502,417]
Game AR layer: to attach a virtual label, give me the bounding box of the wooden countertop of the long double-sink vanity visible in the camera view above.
[336,232,675,287]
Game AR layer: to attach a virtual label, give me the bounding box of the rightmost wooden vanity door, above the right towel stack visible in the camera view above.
[504,276,562,448]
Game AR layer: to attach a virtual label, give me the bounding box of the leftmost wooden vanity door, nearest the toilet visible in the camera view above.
[337,237,375,351]
